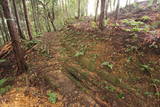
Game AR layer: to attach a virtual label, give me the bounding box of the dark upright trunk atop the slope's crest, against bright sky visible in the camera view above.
[99,0,106,30]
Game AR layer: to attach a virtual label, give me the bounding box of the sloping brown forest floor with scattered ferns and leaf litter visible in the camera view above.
[0,2,160,107]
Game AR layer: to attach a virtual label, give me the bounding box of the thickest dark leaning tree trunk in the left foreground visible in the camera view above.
[2,0,27,74]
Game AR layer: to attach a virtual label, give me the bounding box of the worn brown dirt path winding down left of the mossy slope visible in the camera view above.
[28,33,107,107]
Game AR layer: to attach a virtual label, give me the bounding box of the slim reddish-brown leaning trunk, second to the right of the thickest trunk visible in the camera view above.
[22,0,32,40]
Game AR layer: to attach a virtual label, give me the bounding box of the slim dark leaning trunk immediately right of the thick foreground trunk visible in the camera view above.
[13,0,25,39]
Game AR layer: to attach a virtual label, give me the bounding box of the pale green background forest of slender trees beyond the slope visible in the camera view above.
[0,0,158,45]
